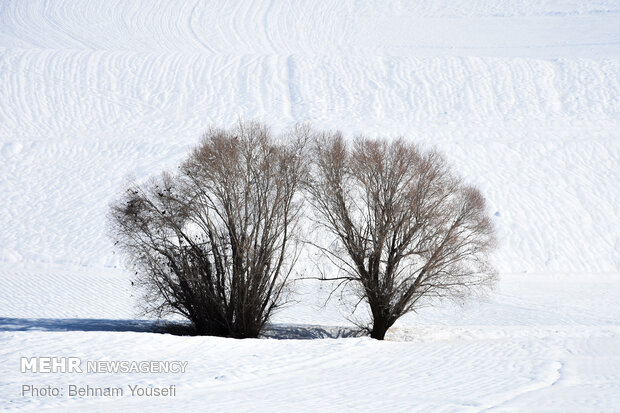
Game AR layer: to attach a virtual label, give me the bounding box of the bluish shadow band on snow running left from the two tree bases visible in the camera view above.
[0,317,365,340]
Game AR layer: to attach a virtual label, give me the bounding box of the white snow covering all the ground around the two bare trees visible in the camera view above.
[0,0,620,412]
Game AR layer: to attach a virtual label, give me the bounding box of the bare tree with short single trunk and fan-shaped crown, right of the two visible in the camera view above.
[307,133,495,340]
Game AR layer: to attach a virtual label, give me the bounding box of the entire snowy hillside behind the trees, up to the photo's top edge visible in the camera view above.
[0,1,620,272]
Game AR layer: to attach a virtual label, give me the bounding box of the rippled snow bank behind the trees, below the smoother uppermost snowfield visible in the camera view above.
[0,49,620,272]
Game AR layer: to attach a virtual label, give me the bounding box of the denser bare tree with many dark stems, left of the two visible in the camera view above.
[110,122,307,338]
